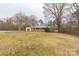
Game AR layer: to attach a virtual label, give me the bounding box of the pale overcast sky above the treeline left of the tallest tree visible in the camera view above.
[0,3,43,19]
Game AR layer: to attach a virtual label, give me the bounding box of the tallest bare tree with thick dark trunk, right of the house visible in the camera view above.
[44,3,66,32]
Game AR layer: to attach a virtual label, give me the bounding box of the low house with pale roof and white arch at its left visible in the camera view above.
[26,20,50,32]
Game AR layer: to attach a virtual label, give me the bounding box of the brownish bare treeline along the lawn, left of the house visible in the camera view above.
[0,12,37,30]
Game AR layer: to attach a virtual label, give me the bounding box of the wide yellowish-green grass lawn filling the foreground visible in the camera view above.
[0,32,79,56]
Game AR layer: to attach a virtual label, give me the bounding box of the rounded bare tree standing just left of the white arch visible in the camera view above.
[14,13,29,30]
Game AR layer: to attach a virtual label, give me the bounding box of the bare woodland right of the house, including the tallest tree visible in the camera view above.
[43,3,79,35]
